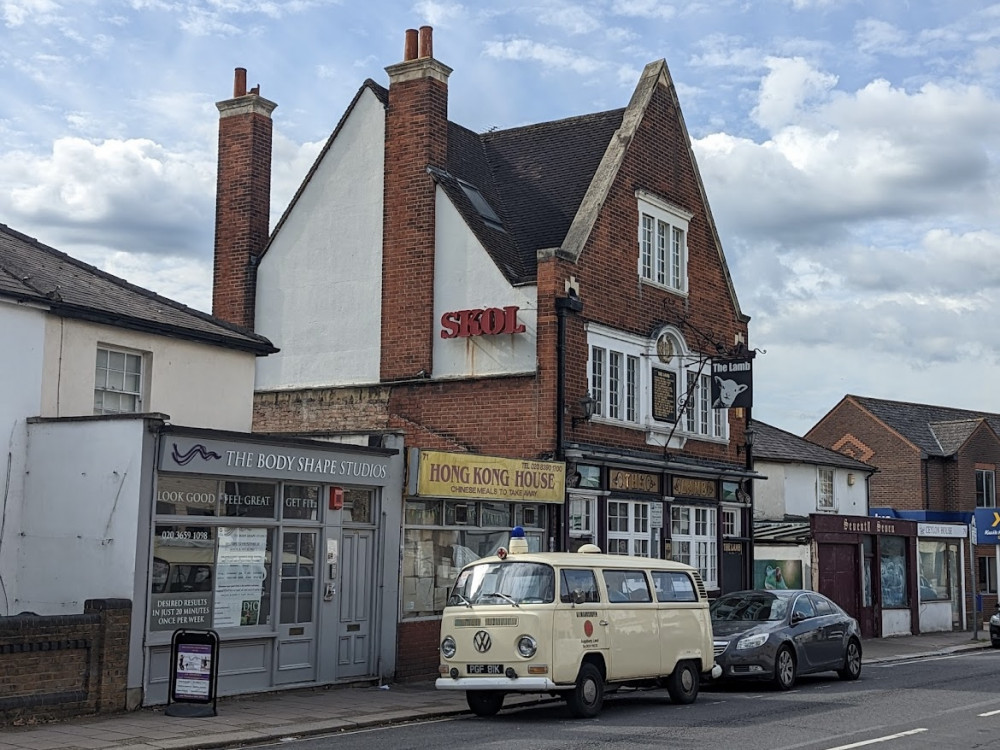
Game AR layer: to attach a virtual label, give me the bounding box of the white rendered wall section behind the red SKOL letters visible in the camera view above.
[432,188,538,378]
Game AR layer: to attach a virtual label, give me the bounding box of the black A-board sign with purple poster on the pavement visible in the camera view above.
[164,630,219,716]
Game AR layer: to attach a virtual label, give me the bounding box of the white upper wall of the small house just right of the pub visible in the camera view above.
[754,461,868,521]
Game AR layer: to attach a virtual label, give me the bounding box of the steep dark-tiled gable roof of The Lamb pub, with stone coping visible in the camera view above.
[265,59,749,320]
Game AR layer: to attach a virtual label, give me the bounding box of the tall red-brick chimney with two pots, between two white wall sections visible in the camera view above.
[381,26,451,381]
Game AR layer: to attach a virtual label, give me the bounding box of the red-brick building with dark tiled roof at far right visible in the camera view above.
[805,395,1000,632]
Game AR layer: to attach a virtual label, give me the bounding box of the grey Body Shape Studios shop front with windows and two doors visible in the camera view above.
[145,427,403,705]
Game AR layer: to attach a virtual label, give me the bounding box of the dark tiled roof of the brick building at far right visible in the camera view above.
[845,395,1000,456]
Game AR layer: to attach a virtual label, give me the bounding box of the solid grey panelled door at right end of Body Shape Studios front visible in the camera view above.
[337,528,376,679]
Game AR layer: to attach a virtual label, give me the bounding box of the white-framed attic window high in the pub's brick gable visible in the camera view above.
[635,190,694,294]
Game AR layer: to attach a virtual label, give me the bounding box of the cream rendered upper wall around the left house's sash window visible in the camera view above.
[40,315,256,432]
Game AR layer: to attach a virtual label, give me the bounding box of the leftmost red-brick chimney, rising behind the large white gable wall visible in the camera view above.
[212,68,278,329]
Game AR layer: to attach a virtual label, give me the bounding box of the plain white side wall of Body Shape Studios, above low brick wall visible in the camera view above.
[13,419,148,615]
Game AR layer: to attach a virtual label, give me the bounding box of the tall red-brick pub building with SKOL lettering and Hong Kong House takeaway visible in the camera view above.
[214,27,752,679]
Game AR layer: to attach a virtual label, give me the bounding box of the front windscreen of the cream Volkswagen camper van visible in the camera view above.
[448,561,555,606]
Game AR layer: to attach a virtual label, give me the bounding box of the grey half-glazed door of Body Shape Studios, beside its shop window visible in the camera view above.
[274,530,320,685]
